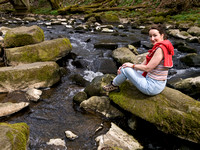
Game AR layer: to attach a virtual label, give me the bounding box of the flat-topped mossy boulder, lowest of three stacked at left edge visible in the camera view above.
[0,62,61,92]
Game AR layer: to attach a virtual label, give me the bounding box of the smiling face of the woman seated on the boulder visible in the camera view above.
[149,29,164,45]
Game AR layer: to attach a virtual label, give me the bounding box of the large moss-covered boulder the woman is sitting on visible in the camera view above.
[109,81,200,143]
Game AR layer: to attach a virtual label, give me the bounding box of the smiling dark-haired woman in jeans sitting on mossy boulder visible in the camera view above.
[103,25,174,95]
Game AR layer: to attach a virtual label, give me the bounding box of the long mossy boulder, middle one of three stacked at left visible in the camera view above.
[5,38,72,65]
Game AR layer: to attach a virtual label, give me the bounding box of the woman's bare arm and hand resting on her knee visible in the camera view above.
[122,48,164,72]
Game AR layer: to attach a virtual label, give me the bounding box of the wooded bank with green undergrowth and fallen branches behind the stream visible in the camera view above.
[0,0,200,26]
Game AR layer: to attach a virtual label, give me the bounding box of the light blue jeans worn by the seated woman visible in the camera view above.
[113,67,167,95]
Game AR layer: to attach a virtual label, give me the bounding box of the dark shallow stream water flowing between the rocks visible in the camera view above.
[0,15,200,150]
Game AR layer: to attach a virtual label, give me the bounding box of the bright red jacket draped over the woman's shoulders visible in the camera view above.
[142,40,174,77]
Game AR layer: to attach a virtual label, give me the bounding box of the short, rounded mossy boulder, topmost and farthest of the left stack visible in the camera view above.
[4,25,44,48]
